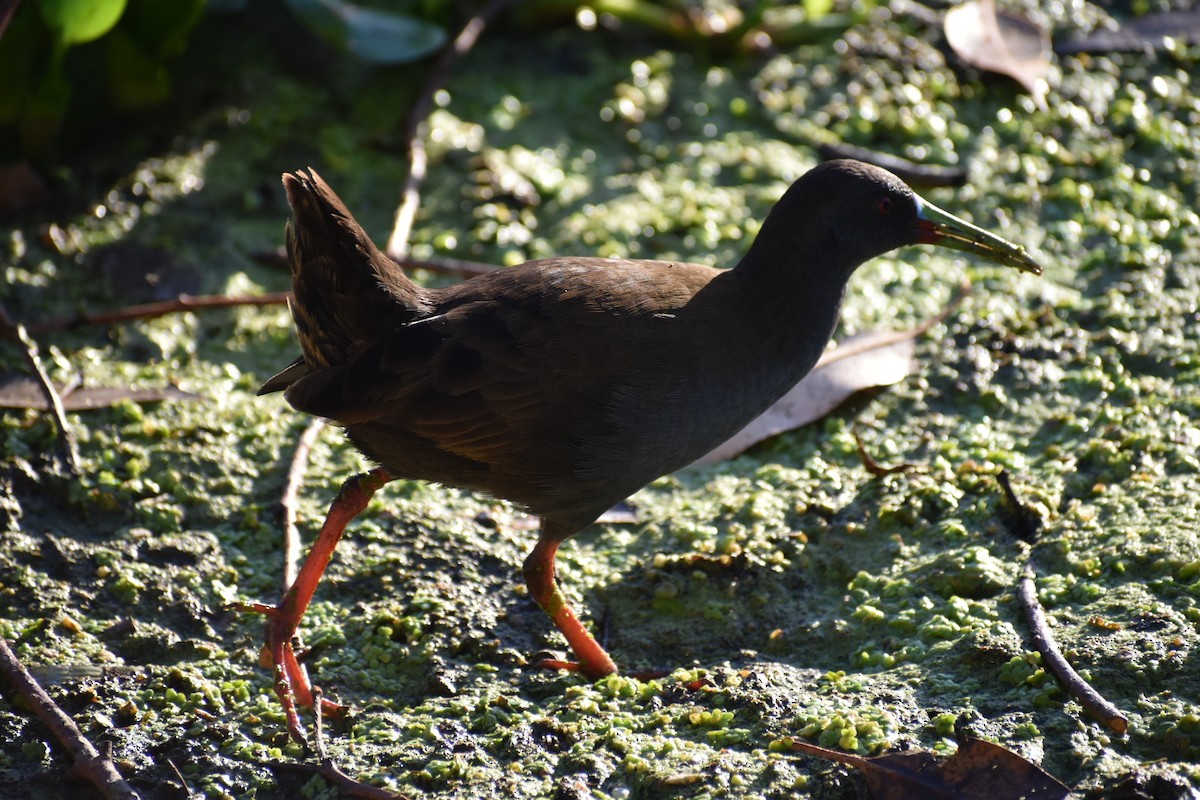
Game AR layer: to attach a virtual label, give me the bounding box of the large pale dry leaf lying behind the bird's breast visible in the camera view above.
[696,325,912,464]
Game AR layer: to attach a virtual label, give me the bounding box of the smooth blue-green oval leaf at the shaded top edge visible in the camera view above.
[288,0,446,64]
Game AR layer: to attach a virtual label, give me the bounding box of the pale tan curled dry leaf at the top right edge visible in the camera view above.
[944,0,1050,109]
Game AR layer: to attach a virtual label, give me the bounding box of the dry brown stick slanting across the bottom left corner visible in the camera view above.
[0,638,138,800]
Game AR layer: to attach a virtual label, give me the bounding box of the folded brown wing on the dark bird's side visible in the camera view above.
[287,259,720,480]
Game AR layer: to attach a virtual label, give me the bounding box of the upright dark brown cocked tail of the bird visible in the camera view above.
[283,168,422,369]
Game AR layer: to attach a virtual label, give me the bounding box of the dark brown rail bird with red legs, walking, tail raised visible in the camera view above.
[248,161,1040,739]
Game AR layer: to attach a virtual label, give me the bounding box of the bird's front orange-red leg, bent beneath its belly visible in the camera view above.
[522,519,617,680]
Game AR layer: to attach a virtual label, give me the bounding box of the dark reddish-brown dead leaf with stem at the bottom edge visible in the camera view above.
[792,739,1070,800]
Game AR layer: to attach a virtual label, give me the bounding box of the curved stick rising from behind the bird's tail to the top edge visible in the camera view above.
[385,0,511,260]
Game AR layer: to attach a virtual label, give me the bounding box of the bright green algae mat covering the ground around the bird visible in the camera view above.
[0,2,1200,799]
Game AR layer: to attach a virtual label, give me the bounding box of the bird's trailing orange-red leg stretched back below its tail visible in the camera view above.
[231,468,391,742]
